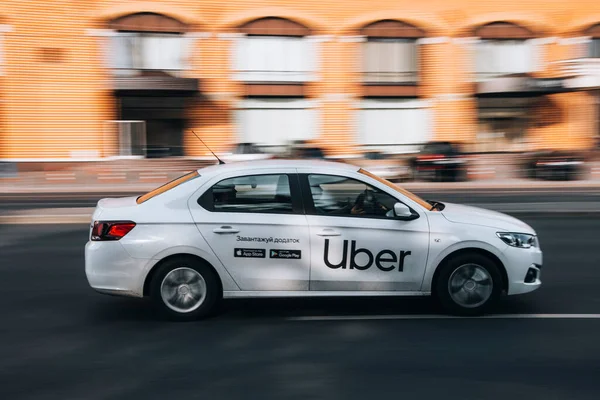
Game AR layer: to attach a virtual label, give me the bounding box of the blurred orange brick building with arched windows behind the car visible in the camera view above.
[0,0,600,161]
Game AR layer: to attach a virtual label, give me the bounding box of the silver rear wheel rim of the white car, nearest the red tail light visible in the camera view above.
[160,267,206,313]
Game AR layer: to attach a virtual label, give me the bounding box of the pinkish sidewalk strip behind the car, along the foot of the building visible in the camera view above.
[0,157,600,194]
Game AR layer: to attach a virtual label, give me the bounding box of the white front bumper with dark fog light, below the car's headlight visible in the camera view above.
[503,247,543,295]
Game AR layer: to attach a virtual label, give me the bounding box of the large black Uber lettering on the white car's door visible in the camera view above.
[323,239,411,272]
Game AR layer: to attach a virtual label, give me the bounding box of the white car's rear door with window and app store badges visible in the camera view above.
[189,169,310,291]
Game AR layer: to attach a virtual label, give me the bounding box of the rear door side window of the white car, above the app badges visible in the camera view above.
[211,175,292,213]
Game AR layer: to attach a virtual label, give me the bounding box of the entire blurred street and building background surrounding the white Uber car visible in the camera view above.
[0,0,600,400]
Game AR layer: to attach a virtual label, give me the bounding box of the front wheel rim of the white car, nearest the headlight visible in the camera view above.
[448,264,494,308]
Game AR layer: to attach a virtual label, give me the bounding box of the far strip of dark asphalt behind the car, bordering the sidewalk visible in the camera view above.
[0,189,600,212]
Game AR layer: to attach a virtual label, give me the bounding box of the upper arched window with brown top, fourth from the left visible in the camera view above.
[474,22,539,81]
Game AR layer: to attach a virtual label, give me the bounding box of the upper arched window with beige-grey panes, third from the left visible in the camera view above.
[360,20,425,85]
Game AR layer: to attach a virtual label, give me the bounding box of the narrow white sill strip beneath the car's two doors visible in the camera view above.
[223,290,431,299]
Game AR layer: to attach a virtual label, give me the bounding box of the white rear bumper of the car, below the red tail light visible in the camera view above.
[85,241,150,297]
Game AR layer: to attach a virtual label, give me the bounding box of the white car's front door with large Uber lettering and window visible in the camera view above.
[301,174,429,291]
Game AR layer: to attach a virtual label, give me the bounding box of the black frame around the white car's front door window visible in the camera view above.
[298,172,421,221]
